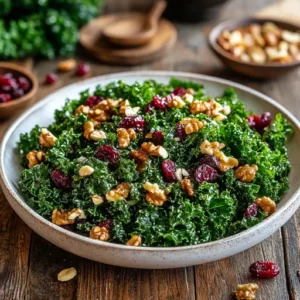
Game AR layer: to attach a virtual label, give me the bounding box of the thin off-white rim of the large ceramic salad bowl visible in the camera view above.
[0,71,300,252]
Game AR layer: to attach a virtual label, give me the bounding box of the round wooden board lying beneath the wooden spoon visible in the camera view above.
[80,14,177,65]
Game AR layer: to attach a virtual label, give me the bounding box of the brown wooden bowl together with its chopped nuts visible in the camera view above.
[209,18,300,79]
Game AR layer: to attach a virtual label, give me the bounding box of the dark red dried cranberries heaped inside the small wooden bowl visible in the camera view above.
[0,73,31,103]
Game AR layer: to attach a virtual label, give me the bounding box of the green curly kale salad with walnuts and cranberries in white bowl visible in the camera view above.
[18,78,292,247]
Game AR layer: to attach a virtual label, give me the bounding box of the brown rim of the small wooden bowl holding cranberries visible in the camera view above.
[0,62,39,109]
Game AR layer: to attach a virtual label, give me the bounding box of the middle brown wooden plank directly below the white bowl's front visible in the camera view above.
[77,259,195,300]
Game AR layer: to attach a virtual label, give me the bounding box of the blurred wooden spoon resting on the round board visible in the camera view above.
[102,0,167,46]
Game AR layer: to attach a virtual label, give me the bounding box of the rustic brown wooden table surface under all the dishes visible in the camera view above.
[0,0,300,300]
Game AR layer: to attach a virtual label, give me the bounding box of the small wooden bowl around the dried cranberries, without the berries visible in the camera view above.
[0,62,38,119]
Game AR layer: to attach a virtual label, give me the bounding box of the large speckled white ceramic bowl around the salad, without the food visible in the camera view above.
[0,71,300,269]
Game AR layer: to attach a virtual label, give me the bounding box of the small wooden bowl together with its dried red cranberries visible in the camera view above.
[0,62,38,119]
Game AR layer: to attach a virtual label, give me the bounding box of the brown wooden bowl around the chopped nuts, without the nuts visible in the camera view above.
[208,18,300,79]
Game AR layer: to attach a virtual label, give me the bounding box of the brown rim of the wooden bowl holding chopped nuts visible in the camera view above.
[208,17,300,69]
